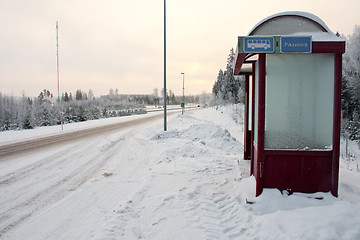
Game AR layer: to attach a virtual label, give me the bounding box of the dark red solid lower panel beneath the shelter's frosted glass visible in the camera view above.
[263,151,332,193]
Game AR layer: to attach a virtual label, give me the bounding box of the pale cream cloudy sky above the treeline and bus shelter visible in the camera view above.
[0,0,360,96]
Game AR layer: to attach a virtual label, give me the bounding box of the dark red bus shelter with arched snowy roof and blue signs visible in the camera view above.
[234,12,345,196]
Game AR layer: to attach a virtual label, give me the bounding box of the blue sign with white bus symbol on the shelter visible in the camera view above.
[244,36,274,53]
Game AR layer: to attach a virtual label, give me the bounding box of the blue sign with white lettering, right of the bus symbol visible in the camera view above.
[280,36,311,53]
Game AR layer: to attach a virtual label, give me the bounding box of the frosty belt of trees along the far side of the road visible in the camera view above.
[0,89,186,131]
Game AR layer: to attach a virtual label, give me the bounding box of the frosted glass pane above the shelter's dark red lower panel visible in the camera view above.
[265,54,334,150]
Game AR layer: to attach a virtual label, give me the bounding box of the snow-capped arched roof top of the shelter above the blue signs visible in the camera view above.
[248,11,339,41]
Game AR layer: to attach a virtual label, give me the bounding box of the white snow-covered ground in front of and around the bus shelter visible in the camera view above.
[0,108,360,239]
